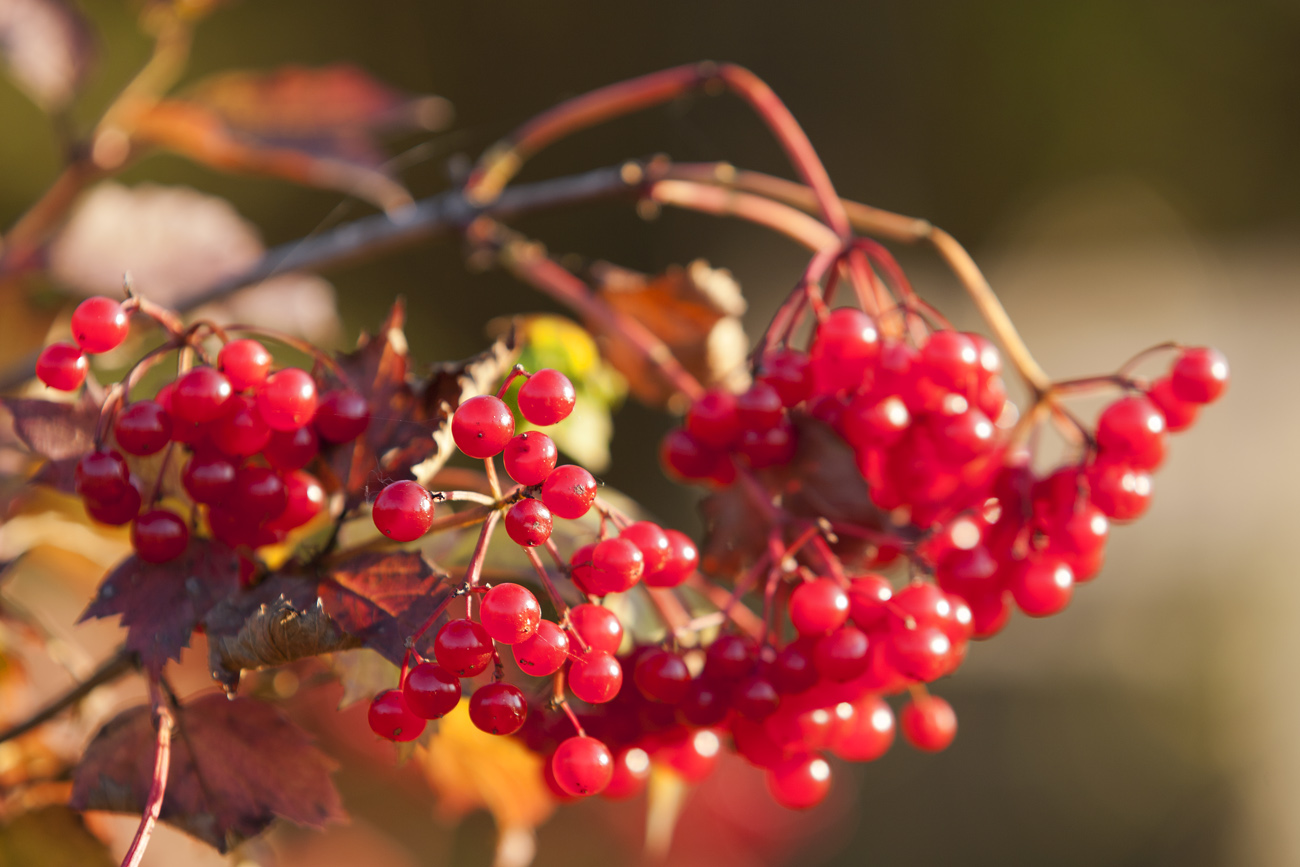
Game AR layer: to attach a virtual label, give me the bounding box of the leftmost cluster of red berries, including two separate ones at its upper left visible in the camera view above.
[40,298,369,563]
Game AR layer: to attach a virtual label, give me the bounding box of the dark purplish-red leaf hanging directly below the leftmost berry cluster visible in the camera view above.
[81,539,239,672]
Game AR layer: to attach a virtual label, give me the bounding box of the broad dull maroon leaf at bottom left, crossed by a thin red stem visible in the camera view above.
[70,693,345,853]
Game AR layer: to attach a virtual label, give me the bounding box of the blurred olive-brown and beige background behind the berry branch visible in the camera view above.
[0,0,1300,867]
